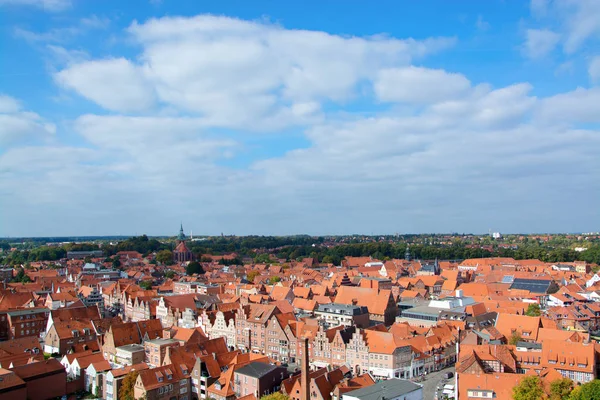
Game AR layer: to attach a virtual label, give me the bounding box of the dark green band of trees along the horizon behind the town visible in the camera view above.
[0,235,600,265]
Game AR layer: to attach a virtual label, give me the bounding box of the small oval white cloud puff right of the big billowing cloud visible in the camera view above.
[374,66,471,103]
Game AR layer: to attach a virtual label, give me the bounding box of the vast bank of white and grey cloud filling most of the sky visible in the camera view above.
[0,16,600,234]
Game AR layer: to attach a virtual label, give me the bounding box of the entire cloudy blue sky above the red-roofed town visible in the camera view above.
[0,0,600,237]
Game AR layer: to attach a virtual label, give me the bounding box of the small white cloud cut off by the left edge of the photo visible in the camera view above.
[0,94,56,147]
